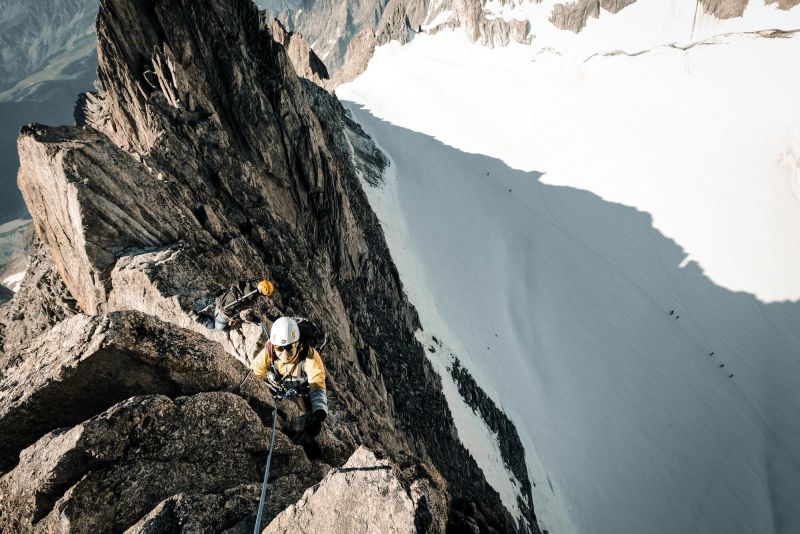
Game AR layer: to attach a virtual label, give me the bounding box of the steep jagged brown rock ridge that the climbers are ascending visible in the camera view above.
[0,0,538,532]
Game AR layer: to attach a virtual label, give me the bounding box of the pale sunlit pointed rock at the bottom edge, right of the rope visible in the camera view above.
[264,447,444,534]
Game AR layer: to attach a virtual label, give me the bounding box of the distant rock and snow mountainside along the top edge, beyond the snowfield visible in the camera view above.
[257,0,800,79]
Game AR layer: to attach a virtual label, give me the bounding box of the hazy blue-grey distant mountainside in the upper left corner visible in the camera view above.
[0,0,98,223]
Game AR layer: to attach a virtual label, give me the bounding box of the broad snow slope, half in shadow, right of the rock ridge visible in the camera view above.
[337,25,800,534]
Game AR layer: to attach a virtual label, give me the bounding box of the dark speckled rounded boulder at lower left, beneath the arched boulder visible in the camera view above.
[0,392,311,533]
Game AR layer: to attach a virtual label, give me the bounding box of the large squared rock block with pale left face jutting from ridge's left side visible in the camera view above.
[18,126,193,313]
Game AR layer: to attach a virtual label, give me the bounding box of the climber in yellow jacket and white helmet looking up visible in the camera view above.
[251,317,328,439]
